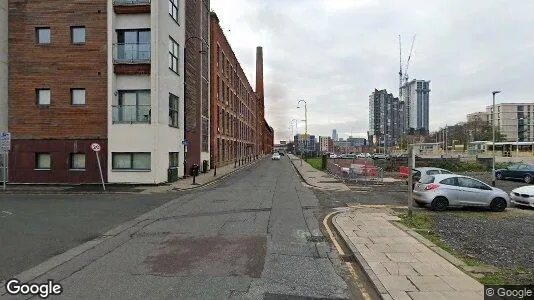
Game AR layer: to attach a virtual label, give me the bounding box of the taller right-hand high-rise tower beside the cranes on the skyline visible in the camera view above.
[399,79,430,132]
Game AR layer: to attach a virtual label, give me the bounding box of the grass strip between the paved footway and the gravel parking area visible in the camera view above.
[399,212,517,284]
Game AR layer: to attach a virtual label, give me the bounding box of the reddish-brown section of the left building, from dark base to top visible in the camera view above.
[8,0,108,183]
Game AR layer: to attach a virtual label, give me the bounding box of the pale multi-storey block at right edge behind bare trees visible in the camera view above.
[486,102,534,142]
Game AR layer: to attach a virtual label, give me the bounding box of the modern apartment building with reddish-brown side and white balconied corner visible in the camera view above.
[8,0,185,183]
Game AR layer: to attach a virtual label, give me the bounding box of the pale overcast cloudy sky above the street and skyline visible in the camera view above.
[211,0,534,143]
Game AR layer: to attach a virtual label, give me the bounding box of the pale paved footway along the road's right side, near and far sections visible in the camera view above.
[290,156,484,300]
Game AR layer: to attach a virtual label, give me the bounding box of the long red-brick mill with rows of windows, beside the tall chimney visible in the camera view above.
[210,12,264,166]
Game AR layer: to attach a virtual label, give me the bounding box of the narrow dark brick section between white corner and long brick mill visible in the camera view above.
[181,0,211,172]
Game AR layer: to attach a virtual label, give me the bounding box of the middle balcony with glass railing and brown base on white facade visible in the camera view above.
[113,43,150,75]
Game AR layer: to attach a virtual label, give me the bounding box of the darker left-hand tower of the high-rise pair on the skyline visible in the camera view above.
[368,89,404,147]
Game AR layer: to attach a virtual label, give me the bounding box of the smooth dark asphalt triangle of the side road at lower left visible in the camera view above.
[0,194,180,282]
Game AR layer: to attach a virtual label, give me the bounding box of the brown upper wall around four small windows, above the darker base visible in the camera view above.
[8,0,107,139]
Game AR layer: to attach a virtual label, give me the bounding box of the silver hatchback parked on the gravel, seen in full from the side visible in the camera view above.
[413,174,510,211]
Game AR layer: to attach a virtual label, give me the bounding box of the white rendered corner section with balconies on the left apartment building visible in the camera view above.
[107,0,185,183]
